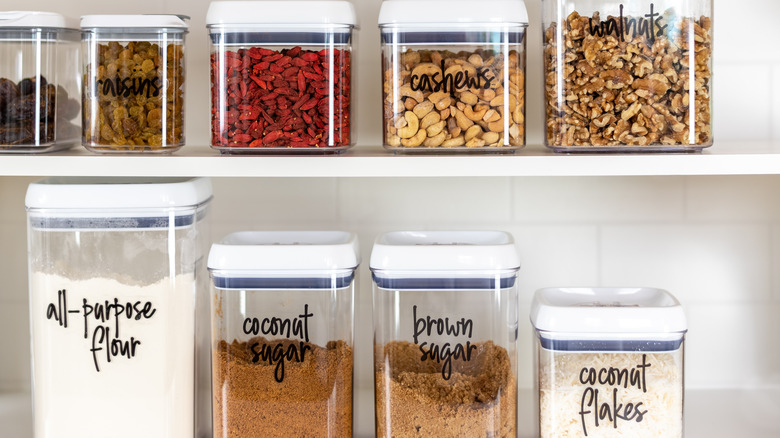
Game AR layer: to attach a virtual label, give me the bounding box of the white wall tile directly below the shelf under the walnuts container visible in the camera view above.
[514,177,685,223]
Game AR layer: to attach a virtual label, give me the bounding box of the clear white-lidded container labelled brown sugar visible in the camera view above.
[371,231,520,438]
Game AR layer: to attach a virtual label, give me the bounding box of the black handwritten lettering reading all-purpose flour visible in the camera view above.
[46,289,157,372]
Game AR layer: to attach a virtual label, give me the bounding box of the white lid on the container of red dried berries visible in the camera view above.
[206,0,357,27]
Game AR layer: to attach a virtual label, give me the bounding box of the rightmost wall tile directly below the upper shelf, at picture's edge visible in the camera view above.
[686,176,780,221]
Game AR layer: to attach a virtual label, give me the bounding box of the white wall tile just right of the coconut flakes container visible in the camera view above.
[685,303,780,389]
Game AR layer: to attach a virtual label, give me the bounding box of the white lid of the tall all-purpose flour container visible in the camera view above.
[25,177,212,212]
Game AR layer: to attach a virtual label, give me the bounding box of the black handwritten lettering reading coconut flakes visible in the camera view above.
[578,354,651,436]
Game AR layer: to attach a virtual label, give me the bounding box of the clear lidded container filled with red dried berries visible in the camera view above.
[206,0,357,154]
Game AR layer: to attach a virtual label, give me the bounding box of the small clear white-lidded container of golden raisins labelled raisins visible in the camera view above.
[81,15,189,153]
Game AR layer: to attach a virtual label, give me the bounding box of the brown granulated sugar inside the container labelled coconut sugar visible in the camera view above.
[213,338,353,438]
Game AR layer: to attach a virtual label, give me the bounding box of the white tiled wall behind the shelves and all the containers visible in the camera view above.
[0,0,780,438]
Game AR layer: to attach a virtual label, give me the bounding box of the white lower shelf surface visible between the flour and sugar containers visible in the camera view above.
[0,388,780,438]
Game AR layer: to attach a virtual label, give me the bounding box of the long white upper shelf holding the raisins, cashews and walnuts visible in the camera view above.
[0,141,780,178]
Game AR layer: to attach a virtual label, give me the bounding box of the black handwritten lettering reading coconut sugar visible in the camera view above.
[243,304,314,383]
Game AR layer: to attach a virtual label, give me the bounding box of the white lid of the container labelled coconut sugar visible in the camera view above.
[208,231,360,276]
